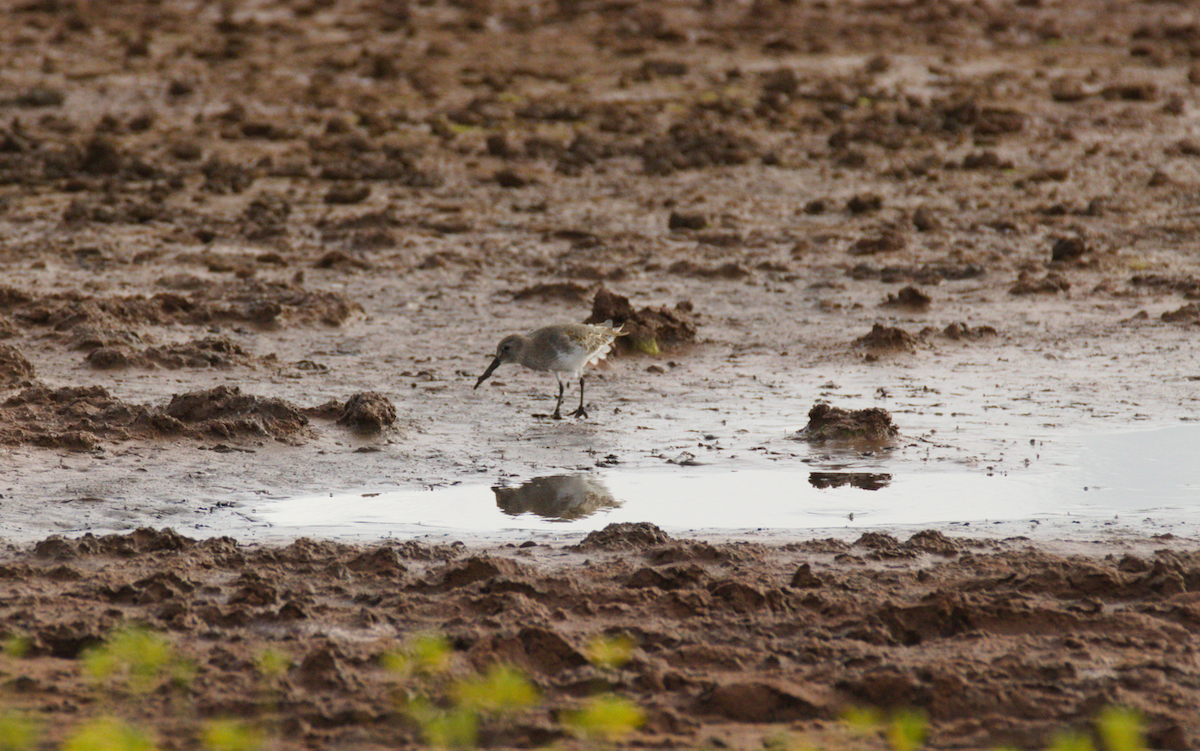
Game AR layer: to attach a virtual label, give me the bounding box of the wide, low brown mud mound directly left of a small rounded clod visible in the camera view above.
[164,385,311,443]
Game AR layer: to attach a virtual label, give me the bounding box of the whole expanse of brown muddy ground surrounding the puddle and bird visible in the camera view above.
[0,0,1200,747]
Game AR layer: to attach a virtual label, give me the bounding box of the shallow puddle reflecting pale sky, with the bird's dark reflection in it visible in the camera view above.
[254,425,1200,537]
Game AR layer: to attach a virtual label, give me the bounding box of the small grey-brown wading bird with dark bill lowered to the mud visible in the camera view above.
[475,320,625,420]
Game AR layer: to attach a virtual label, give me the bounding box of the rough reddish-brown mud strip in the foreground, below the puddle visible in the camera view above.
[7,524,1200,749]
